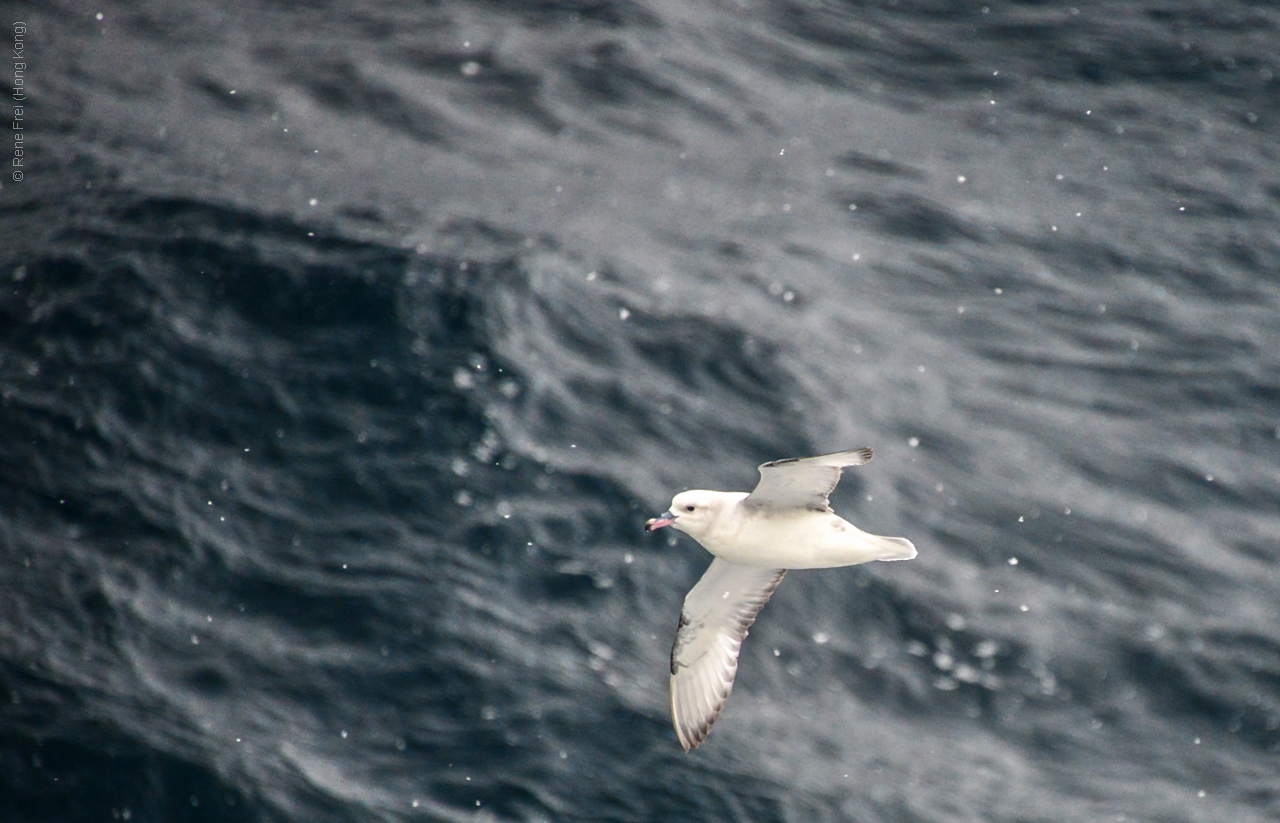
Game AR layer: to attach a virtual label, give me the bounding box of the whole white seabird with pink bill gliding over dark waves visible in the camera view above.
[645,448,915,751]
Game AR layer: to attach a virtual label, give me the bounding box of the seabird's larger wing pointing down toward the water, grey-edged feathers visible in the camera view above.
[671,558,787,751]
